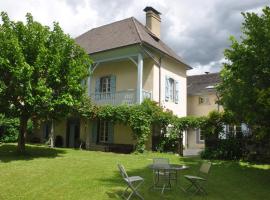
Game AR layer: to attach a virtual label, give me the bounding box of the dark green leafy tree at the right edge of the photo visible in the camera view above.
[218,7,270,135]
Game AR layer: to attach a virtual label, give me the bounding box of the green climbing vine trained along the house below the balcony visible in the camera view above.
[76,100,205,152]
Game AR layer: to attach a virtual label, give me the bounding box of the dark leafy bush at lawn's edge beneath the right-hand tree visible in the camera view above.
[201,112,270,163]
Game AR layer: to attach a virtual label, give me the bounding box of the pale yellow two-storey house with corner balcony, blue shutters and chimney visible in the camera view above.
[33,7,191,150]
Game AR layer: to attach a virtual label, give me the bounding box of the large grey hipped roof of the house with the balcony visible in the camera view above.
[75,17,190,68]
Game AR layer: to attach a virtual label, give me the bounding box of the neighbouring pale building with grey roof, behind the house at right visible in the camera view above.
[184,73,222,155]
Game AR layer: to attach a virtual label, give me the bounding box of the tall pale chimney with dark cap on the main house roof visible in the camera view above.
[143,6,161,38]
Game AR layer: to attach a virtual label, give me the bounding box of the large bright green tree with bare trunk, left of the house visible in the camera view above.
[0,12,91,152]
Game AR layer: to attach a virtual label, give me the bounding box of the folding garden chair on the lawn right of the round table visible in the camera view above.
[184,162,211,194]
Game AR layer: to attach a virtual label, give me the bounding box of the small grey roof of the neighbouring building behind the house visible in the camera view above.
[187,73,221,95]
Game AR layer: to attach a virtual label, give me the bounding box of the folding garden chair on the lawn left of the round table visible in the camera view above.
[118,164,144,200]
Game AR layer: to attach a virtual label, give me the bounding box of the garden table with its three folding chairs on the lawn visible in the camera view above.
[118,158,211,200]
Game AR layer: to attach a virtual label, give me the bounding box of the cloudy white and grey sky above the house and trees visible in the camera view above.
[0,0,270,75]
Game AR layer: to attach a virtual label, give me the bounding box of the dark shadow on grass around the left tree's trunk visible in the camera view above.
[0,144,65,163]
